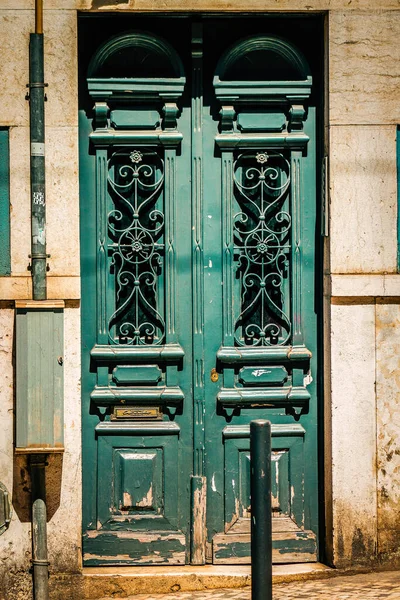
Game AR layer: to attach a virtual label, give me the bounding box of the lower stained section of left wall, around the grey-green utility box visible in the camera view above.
[0,308,81,600]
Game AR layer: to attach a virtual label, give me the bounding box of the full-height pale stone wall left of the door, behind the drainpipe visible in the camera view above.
[0,7,81,600]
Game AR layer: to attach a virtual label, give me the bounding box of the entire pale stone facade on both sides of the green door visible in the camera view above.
[0,0,400,600]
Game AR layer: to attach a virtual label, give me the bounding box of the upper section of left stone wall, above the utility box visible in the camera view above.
[0,9,79,299]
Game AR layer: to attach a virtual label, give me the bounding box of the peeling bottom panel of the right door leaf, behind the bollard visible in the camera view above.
[213,424,317,564]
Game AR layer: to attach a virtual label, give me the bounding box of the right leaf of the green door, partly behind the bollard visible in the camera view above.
[204,27,317,564]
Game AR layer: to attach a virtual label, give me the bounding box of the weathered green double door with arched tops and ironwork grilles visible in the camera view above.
[80,21,318,566]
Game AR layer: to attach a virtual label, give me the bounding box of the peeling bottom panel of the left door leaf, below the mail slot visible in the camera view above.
[83,422,186,565]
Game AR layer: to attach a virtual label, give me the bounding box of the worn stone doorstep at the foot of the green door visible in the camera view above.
[50,563,337,600]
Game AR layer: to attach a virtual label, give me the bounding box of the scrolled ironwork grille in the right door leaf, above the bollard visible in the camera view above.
[233,151,291,346]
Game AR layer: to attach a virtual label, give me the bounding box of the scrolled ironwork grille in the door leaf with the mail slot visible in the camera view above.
[107,149,165,345]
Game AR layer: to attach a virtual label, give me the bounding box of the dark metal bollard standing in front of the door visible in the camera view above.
[250,419,272,600]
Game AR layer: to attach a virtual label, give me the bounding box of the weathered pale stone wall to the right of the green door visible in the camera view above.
[329,5,400,566]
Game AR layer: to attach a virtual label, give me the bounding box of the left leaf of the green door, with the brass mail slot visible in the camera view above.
[80,31,193,566]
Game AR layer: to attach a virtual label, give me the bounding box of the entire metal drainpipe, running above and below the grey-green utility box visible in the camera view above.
[28,0,49,600]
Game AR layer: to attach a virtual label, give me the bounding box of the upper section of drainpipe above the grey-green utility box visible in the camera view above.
[29,0,47,300]
